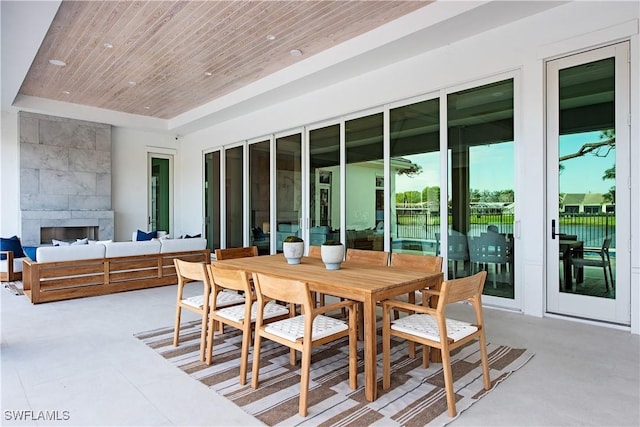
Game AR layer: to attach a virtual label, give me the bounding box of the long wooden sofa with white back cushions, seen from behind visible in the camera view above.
[22,238,211,304]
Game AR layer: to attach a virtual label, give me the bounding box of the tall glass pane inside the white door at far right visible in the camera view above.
[558,58,616,298]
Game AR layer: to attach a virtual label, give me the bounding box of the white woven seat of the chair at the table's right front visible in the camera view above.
[391,314,478,342]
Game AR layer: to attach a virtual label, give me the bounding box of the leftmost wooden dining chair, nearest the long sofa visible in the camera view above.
[173,258,244,362]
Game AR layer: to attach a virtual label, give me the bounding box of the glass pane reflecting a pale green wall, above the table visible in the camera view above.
[345,113,384,251]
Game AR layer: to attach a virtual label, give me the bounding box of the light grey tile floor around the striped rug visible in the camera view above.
[0,286,640,426]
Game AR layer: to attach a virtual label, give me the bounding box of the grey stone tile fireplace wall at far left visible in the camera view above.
[19,112,114,245]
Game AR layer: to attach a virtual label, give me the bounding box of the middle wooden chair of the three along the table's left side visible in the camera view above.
[205,265,289,385]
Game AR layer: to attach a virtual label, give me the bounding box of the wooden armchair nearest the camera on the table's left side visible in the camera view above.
[251,273,358,417]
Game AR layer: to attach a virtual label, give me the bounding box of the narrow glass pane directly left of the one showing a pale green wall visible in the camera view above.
[309,124,340,246]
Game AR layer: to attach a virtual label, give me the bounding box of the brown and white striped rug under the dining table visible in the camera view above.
[135,321,533,426]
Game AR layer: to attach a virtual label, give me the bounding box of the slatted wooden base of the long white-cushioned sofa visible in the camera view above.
[22,249,211,304]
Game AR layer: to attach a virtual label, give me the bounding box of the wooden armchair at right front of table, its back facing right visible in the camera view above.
[382,271,491,417]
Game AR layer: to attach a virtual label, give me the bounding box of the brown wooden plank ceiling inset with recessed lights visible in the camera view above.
[20,0,429,119]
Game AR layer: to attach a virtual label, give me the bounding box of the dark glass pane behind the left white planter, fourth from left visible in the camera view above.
[275,133,302,252]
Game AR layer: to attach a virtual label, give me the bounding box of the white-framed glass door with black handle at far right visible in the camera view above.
[547,43,629,324]
